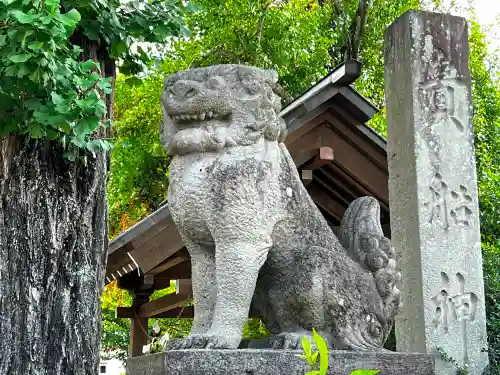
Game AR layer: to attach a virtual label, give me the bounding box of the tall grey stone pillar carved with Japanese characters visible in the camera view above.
[385,11,488,375]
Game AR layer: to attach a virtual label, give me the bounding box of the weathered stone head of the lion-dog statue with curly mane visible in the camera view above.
[160,64,286,155]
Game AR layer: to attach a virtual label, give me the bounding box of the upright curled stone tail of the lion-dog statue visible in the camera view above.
[339,197,401,319]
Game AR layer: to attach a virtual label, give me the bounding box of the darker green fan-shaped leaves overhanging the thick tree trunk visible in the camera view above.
[0,0,196,160]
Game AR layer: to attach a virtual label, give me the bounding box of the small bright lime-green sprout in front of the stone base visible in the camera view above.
[298,329,379,375]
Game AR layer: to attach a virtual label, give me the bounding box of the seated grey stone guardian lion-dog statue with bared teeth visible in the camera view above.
[160,65,400,350]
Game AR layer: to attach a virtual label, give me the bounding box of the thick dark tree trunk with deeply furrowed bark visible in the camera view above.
[0,136,108,375]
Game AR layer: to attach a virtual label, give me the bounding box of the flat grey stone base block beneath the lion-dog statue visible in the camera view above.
[127,349,434,375]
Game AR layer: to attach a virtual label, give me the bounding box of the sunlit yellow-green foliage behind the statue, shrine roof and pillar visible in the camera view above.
[101,0,500,374]
